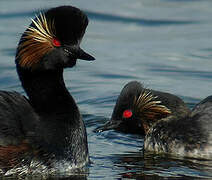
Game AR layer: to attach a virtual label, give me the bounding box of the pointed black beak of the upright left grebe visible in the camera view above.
[64,45,95,61]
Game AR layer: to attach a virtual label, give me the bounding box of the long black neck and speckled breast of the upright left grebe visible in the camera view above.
[17,66,88,164]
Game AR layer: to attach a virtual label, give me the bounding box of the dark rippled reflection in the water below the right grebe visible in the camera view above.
[115,153,212,179]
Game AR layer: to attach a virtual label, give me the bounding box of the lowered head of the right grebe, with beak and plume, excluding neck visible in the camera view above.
[96,81,171,134]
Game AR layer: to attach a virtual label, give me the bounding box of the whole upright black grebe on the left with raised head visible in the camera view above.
[0,6,94,174]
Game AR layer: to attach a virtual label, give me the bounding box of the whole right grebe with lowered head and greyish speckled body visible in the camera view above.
[96,81,212,159]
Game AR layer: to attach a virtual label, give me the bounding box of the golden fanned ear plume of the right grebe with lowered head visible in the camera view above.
[134,90,171,121]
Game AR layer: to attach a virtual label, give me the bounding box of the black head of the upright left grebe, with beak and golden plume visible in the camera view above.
[16,6,94,70]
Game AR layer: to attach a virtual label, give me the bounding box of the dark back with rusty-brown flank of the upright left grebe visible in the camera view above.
[0,91,38,170]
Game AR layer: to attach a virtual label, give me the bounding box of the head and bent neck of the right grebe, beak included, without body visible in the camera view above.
[95,81,190,135]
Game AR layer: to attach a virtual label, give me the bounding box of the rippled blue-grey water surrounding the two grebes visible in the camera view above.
[0,0,212,179]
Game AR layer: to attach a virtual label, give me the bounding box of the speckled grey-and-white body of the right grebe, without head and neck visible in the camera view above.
[144,96,212,159]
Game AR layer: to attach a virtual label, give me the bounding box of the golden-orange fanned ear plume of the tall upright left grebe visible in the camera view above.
[18,13,56,67]
